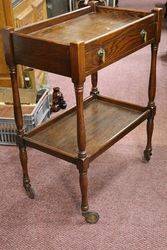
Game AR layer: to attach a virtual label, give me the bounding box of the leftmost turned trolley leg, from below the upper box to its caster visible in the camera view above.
[9,66,34,199]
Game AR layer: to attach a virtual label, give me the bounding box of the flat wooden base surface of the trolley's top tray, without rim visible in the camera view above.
[30,12,139,45]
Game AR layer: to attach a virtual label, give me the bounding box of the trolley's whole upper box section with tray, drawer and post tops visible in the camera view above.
[4,5,161,78]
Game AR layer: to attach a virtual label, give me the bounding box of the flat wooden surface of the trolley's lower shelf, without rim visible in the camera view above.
[30,99,142,157]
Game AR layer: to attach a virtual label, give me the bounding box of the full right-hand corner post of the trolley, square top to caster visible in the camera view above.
[144,8,162,161]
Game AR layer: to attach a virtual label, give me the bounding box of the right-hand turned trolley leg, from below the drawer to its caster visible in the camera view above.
[144,44,158,161]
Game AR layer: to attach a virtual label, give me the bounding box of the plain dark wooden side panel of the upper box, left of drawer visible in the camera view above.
[13,33,71,76]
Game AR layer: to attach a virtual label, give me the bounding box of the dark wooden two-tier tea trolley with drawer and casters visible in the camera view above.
[3,1,162,223]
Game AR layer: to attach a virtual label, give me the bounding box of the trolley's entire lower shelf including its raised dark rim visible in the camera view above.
[24,95,149,163]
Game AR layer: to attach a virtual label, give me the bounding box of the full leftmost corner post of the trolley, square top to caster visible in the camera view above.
[3,28,34,199]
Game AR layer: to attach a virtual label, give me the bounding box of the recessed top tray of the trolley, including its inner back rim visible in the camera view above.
[15,6,153,45]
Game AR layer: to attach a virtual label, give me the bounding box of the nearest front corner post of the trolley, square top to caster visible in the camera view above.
[70,42,99,223]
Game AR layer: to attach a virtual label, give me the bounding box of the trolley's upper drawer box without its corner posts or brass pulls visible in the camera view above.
[9,7,155,77]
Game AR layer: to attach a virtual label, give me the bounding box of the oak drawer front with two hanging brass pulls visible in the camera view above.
[85,22,156,75]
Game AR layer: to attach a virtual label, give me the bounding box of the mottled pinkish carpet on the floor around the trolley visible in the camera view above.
[0,0,167,250]
